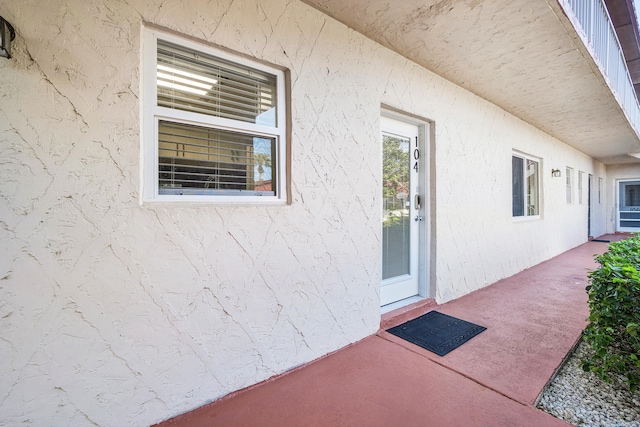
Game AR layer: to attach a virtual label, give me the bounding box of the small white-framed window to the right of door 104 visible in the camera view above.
[511,153,540,217]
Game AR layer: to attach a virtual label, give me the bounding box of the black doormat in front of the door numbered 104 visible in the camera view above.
[387,311,487,356]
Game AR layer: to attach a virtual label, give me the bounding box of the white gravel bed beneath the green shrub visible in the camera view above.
[537,342,640,427]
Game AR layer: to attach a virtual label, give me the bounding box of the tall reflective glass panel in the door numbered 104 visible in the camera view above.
[382,134,411,279]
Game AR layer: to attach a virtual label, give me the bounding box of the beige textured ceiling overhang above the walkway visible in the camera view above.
[303,0,640,164]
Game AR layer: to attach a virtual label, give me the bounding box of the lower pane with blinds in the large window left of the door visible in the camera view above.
[158,120,276,195]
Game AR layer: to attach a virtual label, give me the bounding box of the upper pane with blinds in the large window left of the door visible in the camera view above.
[157,40,277,127]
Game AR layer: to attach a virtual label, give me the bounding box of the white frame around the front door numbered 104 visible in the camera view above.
[378,107,435,312]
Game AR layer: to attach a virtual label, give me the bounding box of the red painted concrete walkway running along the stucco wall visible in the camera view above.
[160,235,626,427]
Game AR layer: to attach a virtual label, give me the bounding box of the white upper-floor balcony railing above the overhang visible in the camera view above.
[560,0,640,133]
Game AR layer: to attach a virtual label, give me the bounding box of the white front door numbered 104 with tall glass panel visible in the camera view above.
[380,117,426,305]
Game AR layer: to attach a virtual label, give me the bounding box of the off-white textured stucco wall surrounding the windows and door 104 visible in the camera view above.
[0,0,598,426]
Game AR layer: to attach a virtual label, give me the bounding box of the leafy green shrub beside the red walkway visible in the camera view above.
[582,234,640,391]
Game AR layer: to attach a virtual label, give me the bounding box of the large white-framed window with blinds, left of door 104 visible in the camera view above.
[143,29,286,202]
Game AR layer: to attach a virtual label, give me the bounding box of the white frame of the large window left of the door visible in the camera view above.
[141,27,287,204]
